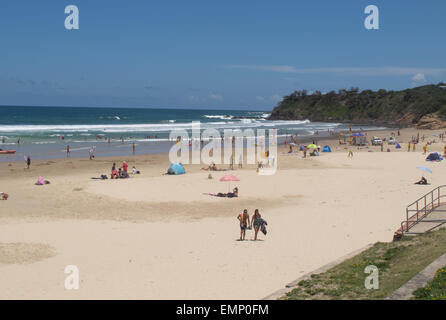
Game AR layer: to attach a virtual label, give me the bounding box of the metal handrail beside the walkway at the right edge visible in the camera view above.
[397,185,446,233]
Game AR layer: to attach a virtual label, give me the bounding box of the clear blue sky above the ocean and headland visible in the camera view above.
[0,0,446,110]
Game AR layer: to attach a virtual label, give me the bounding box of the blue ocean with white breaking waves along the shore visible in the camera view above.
[0,106,382,161]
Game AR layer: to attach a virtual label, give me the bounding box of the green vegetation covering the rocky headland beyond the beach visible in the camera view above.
[270,83,446,126]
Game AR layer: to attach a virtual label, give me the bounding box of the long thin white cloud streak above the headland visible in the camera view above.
[227,65,446,76]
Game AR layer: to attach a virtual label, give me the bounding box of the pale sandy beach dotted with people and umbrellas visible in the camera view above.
[0,129,446,299]
